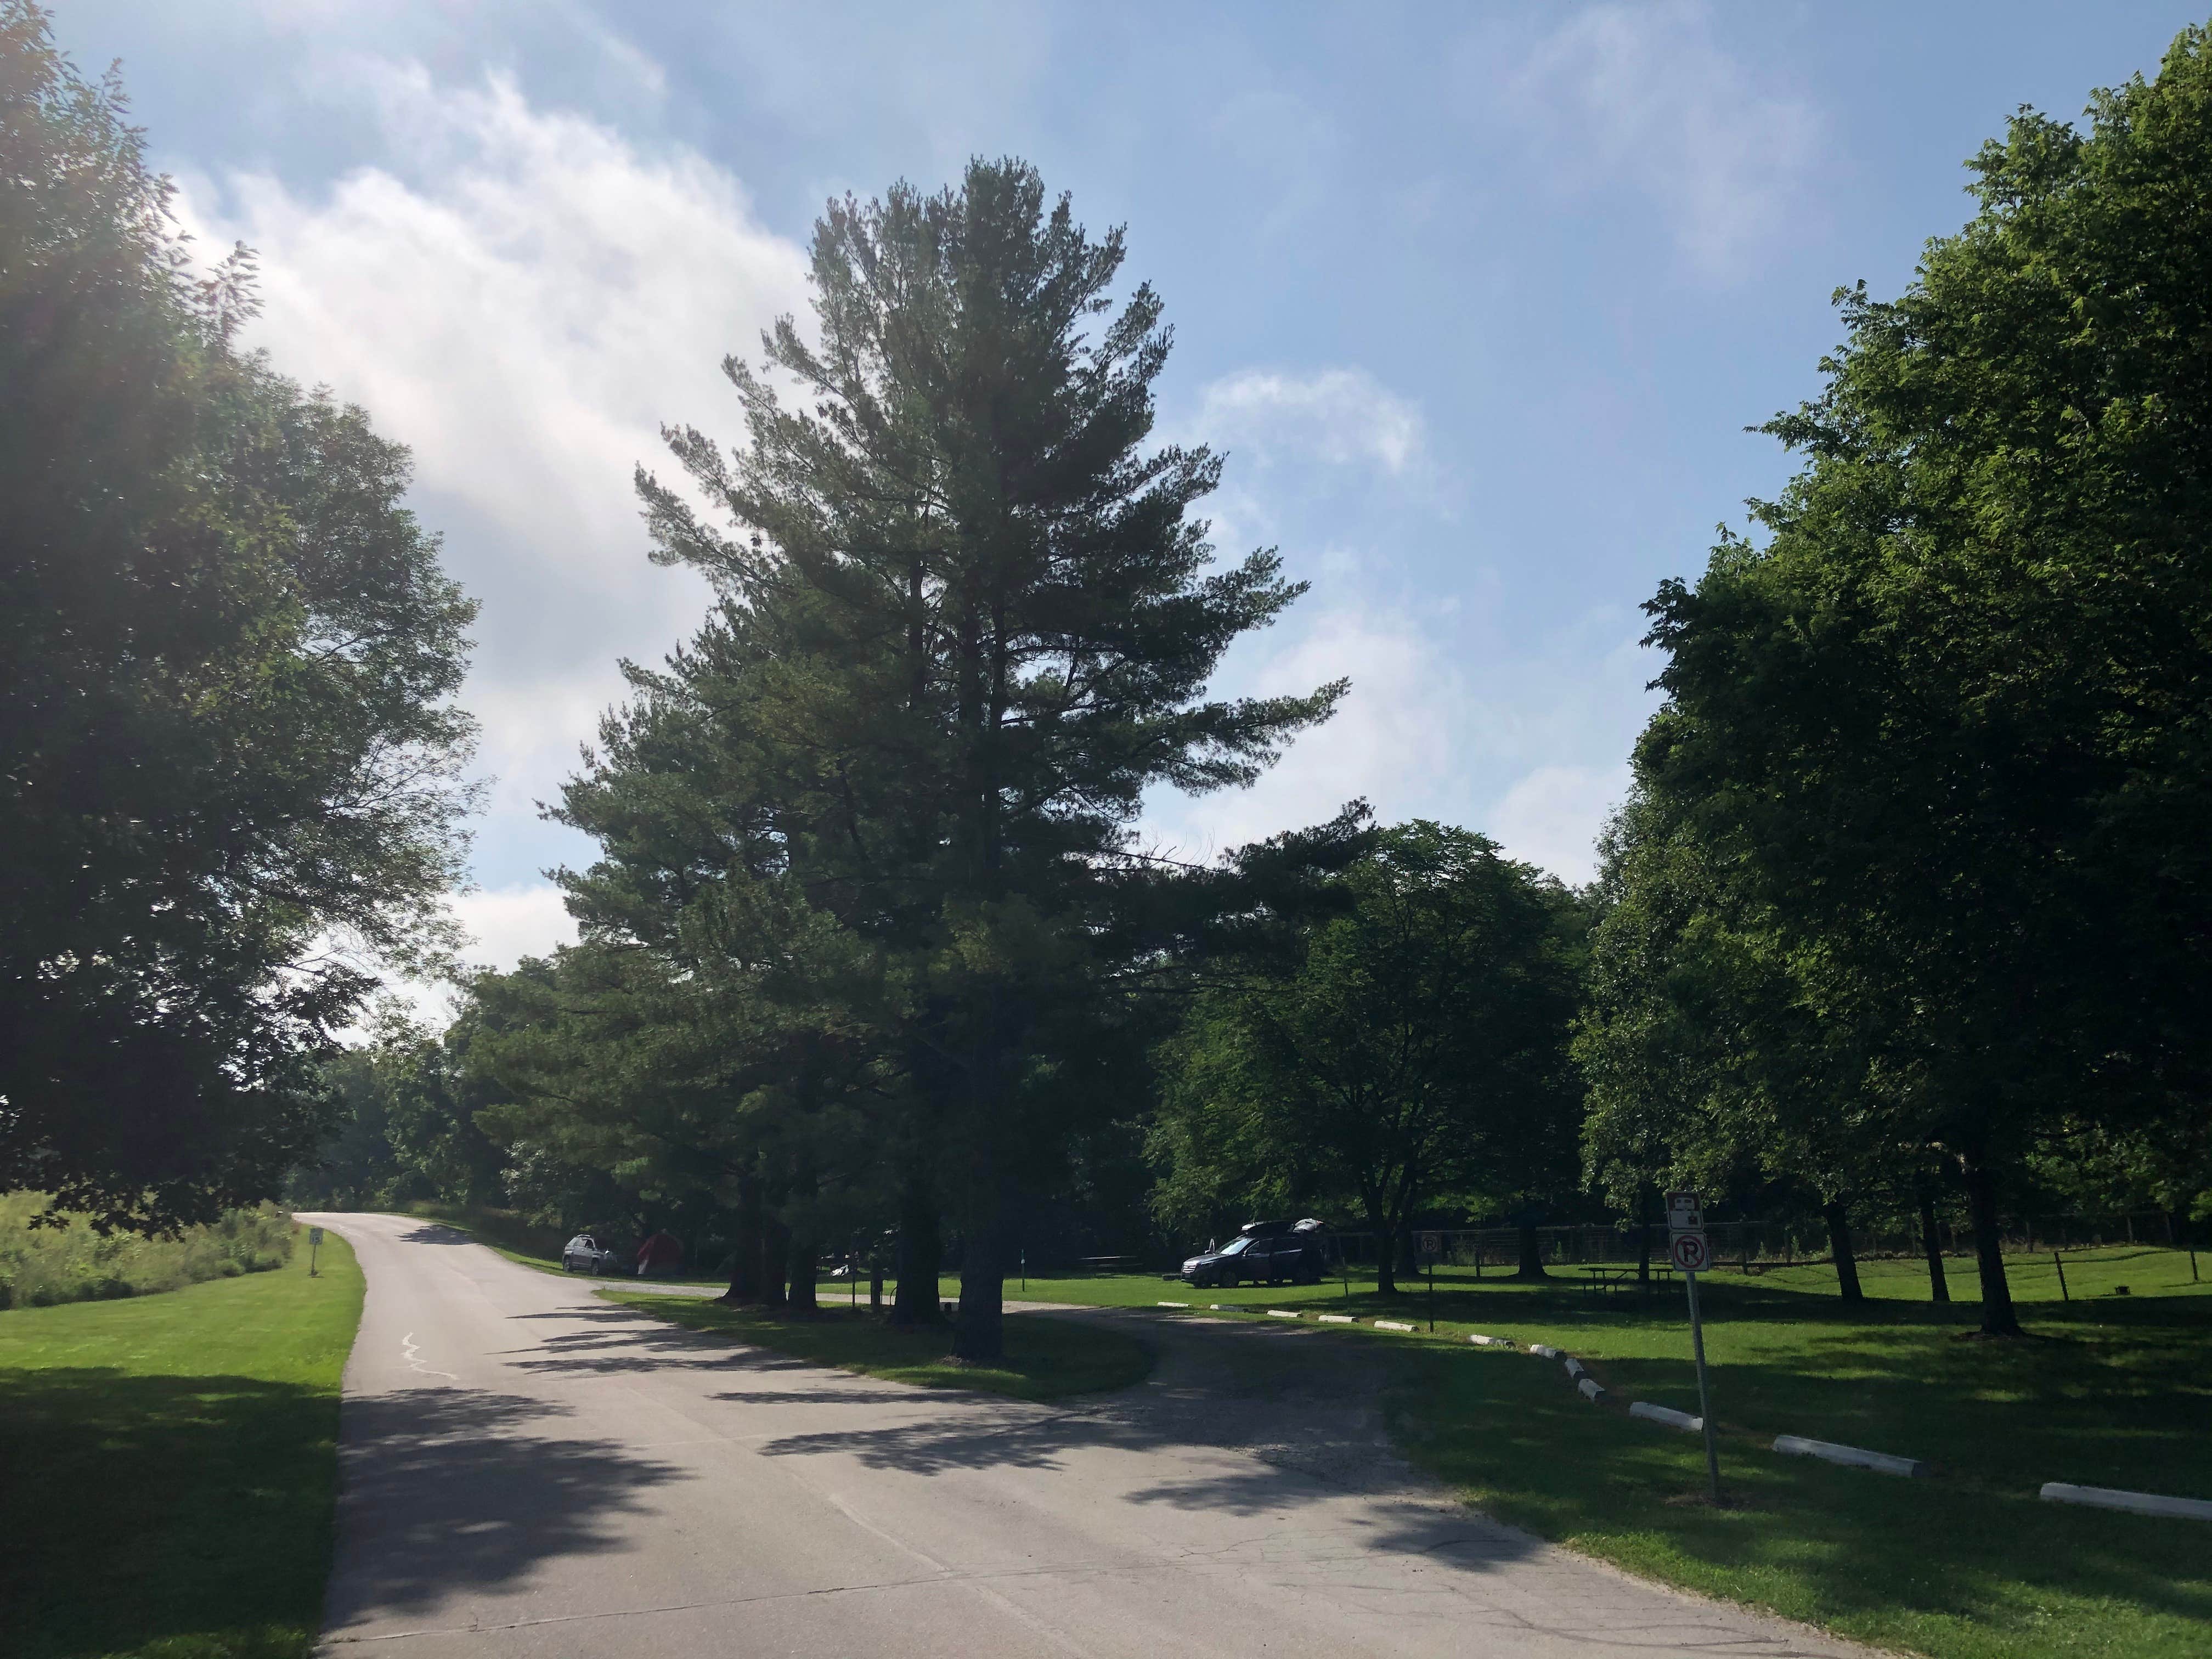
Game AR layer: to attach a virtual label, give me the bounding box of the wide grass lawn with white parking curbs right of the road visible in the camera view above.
[955,1245,2212,1659]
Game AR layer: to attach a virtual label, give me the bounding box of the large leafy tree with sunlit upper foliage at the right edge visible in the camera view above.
[1637,29,2212,1334]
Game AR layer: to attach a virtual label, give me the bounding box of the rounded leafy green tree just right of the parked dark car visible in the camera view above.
[1155,821,1579,1294]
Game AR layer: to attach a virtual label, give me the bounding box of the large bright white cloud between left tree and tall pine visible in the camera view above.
[186,60,805,878]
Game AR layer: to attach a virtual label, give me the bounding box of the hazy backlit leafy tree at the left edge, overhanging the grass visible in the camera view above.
[0,0,473,1230]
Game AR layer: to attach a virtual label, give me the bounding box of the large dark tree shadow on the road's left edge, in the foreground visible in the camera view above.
[325,1389,684,1630]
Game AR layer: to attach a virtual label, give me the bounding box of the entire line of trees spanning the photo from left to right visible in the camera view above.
[0,0,2212,1358]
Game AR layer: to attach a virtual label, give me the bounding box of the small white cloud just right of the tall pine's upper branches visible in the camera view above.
[1197,369,1425,478]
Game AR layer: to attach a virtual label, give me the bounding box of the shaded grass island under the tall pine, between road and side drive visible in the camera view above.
[602,1290,1153,1400]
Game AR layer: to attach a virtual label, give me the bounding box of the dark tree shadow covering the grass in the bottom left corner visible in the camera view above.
[0,1367,338,1659]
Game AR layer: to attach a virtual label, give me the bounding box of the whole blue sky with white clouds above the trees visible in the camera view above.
[58,0,2203,982]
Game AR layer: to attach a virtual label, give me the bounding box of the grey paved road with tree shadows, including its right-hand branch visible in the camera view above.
[303,1215,1858,1659]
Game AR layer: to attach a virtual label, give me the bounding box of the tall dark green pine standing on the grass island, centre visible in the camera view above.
[544,161,1340,1358]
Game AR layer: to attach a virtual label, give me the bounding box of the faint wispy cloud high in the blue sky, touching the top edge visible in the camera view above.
[1504,0,1822,281]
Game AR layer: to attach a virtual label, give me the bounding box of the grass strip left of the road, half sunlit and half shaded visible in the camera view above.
[0,1234,360,1659]
